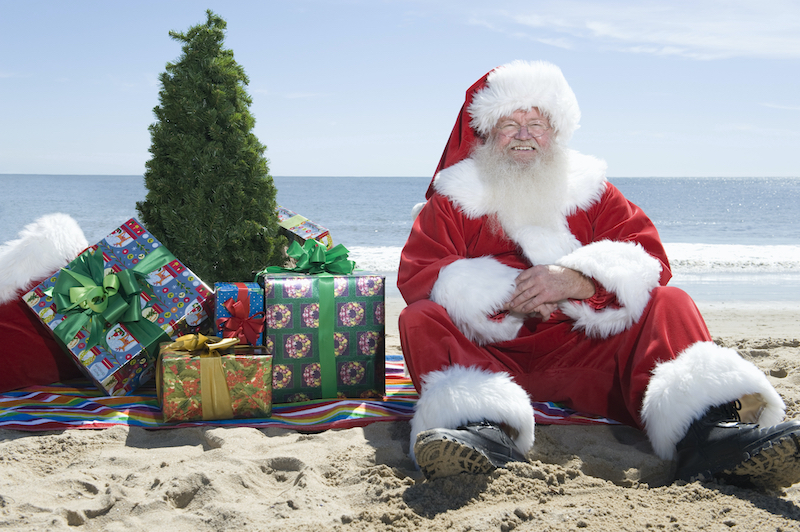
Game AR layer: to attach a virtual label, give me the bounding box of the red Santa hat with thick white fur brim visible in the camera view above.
[425,61,581,198]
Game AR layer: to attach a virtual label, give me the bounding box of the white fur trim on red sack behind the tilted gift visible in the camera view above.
[0,213,89,304]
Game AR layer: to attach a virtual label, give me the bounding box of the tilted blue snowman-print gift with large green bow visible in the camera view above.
[23,219,211,395]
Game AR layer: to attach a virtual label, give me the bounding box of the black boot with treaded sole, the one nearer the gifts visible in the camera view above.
[414,421,526,479]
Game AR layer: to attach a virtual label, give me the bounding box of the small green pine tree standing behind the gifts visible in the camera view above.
[136,10,286,285]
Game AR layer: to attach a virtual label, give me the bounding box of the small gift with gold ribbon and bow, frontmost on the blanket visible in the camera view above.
[156,334,272,422]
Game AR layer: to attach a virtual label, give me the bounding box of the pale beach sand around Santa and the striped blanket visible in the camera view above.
[0,297,800,532]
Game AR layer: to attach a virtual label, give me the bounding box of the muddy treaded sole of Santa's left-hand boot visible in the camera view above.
[414,433,497,480]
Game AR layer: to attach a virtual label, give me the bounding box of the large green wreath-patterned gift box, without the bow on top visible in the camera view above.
[258,272,385,403]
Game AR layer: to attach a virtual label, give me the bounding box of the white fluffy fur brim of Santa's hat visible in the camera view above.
[469,61,581,142]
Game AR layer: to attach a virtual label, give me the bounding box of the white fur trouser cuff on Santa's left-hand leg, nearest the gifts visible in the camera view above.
[410,364,534,460]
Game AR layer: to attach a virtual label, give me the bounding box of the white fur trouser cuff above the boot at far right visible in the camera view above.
[642,342,786,460]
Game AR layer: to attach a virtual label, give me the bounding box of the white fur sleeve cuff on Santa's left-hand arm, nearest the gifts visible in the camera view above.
[430,257,525,344]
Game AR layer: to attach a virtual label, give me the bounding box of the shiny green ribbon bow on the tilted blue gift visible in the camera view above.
[47,247,175,354]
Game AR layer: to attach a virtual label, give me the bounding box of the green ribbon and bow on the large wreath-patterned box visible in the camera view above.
[256,240,356,399]
